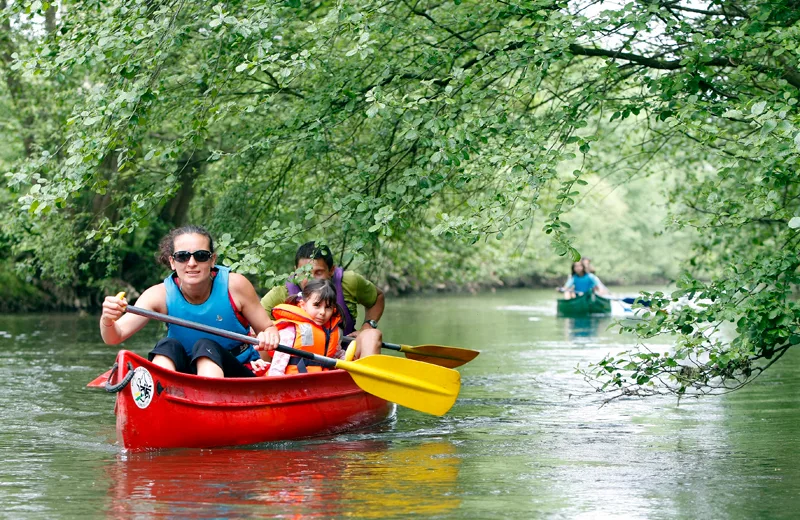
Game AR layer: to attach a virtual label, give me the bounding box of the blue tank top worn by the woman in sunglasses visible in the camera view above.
[164,265,252,363]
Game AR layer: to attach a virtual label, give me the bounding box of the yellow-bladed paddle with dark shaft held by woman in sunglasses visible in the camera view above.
[113,305,461,415]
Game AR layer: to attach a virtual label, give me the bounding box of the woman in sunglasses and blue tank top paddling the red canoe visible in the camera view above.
[100,226,278,377]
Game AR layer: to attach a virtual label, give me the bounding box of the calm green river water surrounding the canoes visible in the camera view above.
[0,290,800,519]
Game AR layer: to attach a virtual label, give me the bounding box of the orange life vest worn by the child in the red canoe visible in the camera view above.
[272,303,342,374]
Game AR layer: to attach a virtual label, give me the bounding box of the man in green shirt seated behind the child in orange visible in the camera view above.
[261,241,384,358]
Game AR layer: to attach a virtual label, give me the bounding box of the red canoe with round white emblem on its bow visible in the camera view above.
[89,350,395,451]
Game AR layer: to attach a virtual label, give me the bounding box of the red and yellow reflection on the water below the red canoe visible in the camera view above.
[106,440,460,518]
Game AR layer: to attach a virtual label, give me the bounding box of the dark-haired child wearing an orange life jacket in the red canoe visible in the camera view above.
[267,279,344,376]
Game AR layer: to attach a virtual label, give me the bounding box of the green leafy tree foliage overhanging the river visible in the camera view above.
[0,0,800,393]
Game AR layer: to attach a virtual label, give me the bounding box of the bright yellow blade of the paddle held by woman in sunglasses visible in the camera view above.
[336,355,461,415]
